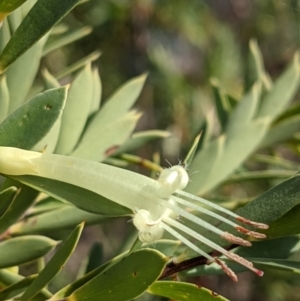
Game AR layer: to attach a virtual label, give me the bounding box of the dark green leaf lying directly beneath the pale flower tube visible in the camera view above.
[11,176,132,216]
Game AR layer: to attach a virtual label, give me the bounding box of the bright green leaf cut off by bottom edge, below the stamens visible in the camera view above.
[147,281,228,301]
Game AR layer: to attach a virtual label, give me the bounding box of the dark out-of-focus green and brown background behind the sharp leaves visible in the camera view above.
[46,0,300,301]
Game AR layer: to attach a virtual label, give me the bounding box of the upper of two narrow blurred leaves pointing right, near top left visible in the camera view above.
[43,26,92,56]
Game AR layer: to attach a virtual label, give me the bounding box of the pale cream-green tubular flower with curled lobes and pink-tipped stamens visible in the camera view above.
[0,147,268,281]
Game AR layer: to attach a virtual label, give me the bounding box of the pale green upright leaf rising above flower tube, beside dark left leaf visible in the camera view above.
[55,64,93,155]
